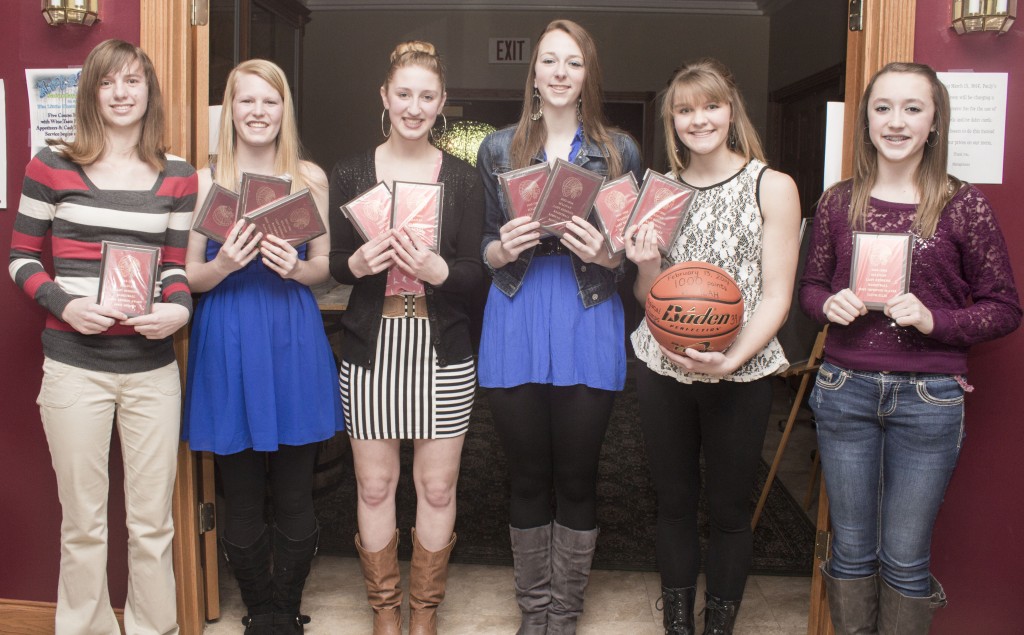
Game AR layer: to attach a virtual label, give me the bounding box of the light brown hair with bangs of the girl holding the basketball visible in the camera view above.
[662,57,767,178]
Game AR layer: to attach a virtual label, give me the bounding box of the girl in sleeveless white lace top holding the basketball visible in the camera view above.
[626,59,800,634]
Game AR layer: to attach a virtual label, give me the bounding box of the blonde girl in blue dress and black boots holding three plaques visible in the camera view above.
[182,59,344,633]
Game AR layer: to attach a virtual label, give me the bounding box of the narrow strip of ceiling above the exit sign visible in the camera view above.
[306,0,794,15]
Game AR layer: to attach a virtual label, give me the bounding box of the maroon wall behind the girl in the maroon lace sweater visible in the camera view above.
[913,0,1024,635]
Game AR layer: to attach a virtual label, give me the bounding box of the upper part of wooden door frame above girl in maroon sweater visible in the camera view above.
[843,0,916,178]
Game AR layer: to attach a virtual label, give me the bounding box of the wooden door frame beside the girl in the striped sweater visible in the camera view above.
[140,0,219,635]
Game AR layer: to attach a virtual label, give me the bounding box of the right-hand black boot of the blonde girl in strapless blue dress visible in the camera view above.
[272,525,319,635]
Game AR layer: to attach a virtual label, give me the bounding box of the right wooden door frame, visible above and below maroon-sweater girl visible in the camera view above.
[807,0,916,635]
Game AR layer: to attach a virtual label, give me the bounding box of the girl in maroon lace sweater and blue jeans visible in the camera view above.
[800,64,1021,633]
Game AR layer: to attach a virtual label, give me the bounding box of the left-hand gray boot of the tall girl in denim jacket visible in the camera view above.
[509,523,551,635]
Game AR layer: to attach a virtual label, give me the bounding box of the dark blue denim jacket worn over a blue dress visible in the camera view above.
[476,126,643,307]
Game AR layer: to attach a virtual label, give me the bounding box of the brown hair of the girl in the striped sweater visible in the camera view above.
[55,40,167,170]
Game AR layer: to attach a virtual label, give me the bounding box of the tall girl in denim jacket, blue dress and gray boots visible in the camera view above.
[477,19,641,634]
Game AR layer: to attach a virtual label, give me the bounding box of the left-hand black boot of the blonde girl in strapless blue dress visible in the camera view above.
[220,526,273,635]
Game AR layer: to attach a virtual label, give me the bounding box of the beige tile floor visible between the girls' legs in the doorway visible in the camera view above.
[205,386,817,635]
